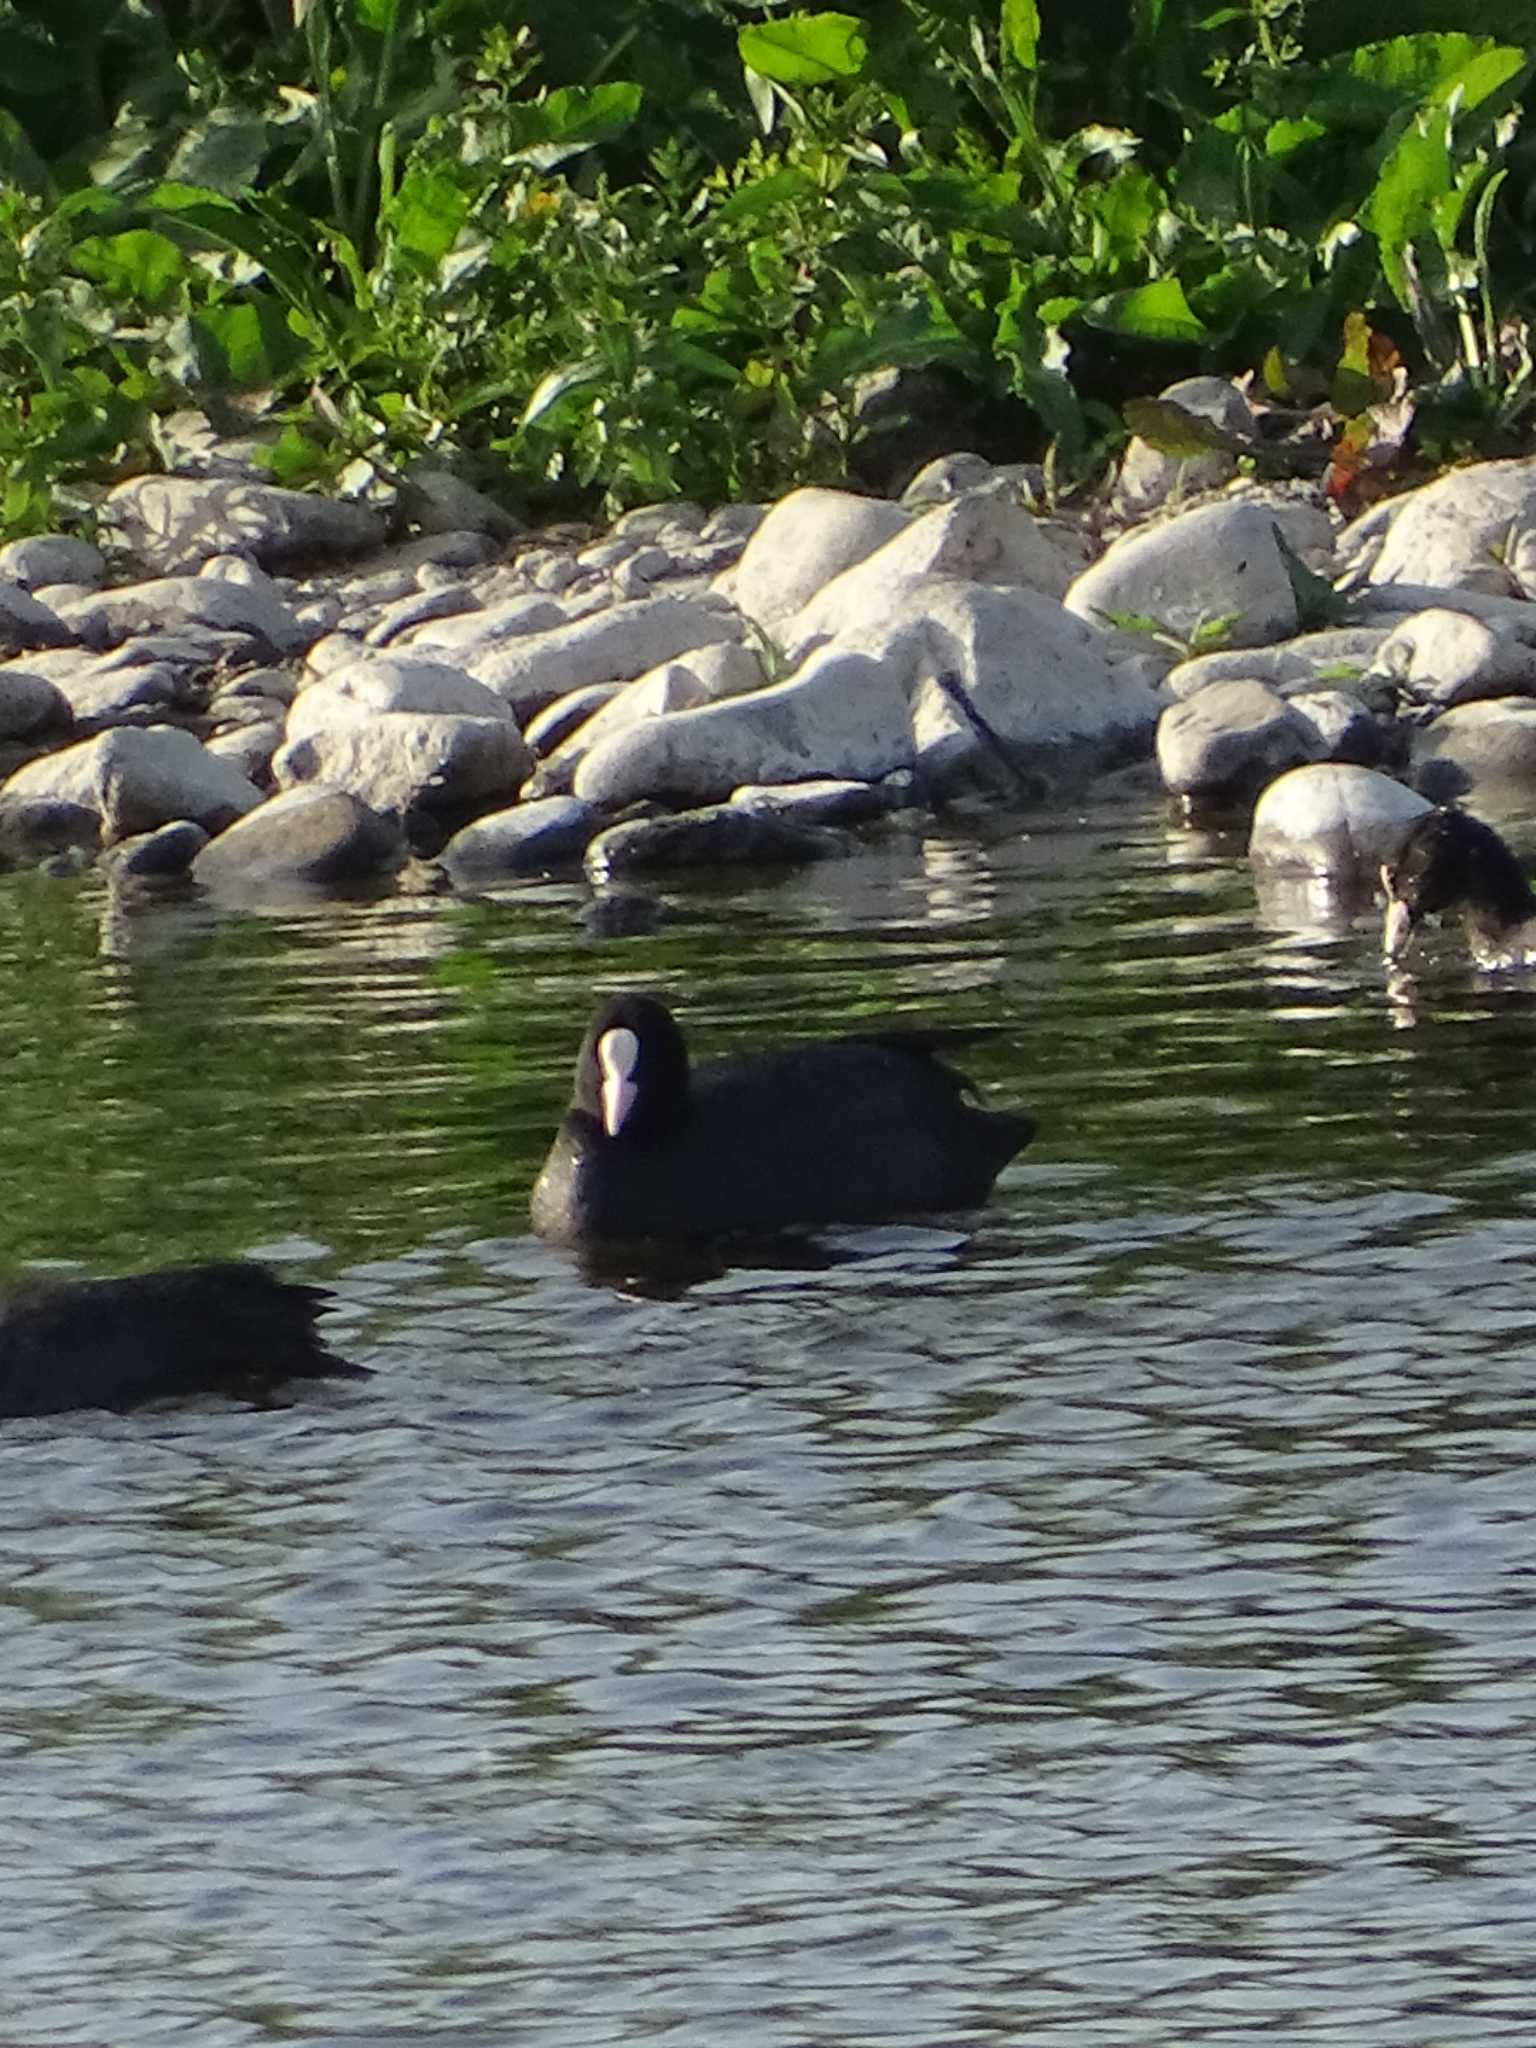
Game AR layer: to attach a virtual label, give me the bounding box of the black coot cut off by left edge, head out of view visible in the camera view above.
[0,1260,371,1415]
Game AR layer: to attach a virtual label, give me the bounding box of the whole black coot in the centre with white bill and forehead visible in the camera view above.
[532,993,1034,1245]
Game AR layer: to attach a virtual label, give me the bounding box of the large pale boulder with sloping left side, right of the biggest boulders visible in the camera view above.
[1067,500,1331,647]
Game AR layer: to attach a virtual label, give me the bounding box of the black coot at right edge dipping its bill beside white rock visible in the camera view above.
[1380,807,1536,967]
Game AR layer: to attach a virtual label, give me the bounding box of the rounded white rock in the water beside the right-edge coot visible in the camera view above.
[1247,762,1434,885]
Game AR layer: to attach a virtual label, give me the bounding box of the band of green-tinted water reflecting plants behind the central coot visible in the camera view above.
[0,807,1536,1272]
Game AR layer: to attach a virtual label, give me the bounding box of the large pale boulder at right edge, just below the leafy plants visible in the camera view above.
[1339,457,1536,598]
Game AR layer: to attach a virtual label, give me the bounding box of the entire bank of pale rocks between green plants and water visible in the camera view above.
[0,379,1536,899]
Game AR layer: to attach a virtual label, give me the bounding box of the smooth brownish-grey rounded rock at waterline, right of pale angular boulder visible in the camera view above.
[193,784,408,895]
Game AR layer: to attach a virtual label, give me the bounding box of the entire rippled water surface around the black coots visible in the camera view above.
[0,805,1536,2048]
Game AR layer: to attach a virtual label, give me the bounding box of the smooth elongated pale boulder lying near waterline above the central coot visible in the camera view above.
[573,649,913,805]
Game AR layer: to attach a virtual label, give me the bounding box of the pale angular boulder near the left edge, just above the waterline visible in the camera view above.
[0,725,262,840]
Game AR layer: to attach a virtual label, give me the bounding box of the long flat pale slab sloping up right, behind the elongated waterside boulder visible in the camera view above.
[473,598,745,721]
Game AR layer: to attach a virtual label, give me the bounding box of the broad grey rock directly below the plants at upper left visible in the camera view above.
[98,477,385,575]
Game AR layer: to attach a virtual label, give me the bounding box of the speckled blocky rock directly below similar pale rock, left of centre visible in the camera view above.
[272,711,528,813]
